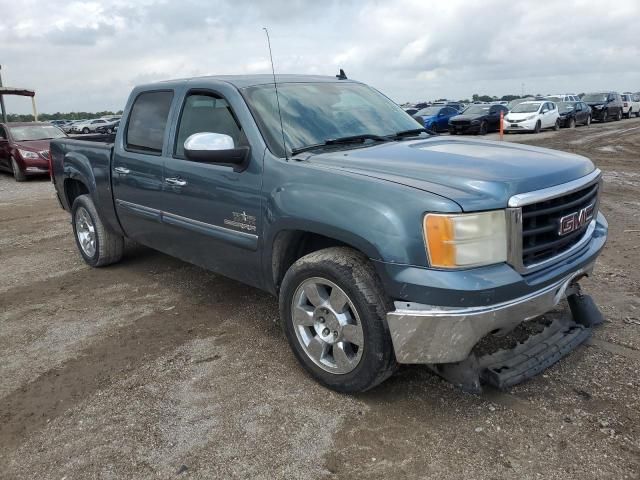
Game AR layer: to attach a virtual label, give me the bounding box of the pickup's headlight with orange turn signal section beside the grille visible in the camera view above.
[423,210,507,268]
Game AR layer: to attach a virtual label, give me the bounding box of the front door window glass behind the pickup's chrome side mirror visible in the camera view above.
[175,93,248,158]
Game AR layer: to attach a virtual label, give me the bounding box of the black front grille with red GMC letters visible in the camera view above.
[522,183,600,267]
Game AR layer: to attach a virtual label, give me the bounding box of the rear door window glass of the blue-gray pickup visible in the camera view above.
[126,92,173,155]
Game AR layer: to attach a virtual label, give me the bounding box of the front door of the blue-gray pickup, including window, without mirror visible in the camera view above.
[162,91,264,285]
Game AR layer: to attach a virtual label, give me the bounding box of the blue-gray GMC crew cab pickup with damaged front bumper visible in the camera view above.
[51,75,607,392]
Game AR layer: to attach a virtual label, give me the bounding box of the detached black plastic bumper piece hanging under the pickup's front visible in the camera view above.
[430,291,603,393]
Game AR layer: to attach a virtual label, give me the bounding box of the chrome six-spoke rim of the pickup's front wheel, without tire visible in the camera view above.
[291,277,364,374]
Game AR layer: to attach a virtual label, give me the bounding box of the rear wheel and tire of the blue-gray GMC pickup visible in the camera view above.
[71,195,124,267]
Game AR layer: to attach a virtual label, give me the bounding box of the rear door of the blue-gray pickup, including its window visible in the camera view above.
[111,90,174,250]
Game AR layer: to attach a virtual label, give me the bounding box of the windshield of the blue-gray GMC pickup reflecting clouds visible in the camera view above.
[243,82,421,157]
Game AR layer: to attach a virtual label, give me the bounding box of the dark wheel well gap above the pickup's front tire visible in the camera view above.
[271,230,353,292]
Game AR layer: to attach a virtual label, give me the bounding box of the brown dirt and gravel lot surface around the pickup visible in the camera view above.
[0,119,640,480]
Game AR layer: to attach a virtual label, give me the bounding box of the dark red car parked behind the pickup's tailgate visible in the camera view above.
[0,122,67,182]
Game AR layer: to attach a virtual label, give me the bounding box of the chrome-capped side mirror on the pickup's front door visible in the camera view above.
[184,132,250,166]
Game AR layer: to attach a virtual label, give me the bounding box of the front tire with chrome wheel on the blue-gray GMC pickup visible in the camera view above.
[280,247,397,393]
